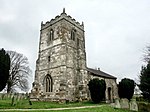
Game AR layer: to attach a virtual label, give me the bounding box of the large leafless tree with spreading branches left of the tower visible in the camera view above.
[7,51,31,93]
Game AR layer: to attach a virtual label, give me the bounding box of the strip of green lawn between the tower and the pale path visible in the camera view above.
[0,99,100,109]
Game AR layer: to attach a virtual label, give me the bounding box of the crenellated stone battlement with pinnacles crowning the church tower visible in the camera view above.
[41,8,84,30]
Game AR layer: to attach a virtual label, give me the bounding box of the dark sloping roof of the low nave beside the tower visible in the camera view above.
[87,68,117,79]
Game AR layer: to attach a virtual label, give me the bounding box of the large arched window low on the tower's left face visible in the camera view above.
[44,74,53,92]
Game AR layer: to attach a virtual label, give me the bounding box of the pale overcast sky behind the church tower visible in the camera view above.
[0,0,150,87]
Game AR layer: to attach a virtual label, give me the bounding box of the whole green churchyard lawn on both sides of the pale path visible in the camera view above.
[0,99,131,112]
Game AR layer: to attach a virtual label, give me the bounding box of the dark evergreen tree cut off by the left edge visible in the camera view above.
[0,49,10,91]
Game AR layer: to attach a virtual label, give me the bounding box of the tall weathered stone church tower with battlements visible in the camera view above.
[30,9,88,101]
